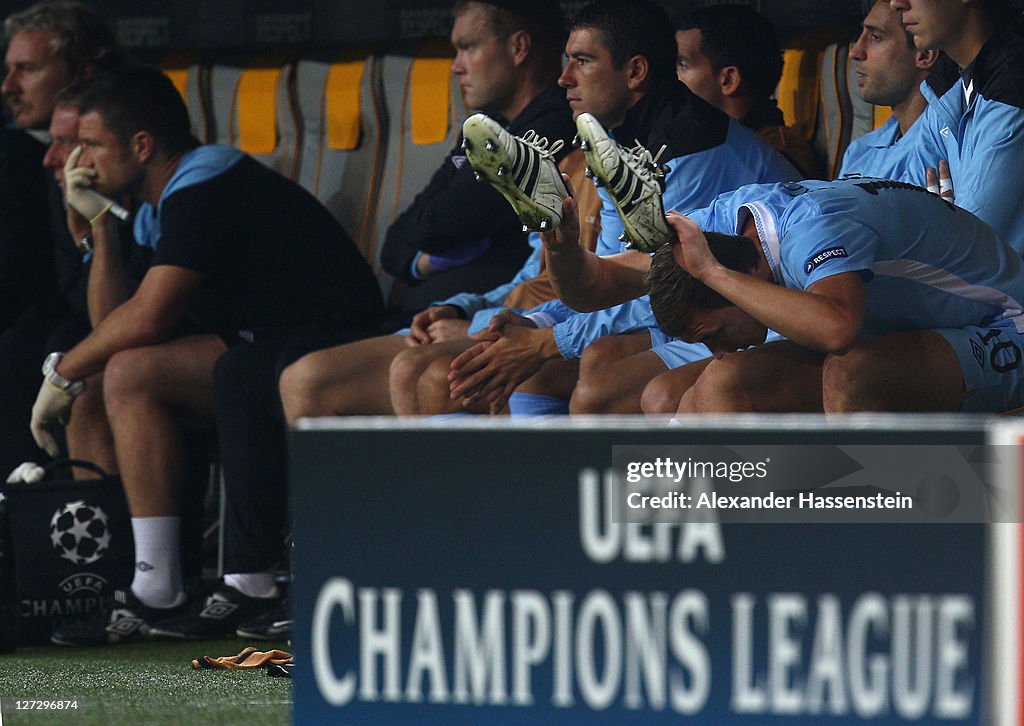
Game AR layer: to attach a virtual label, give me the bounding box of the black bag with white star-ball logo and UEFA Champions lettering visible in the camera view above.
[0,460,135,650]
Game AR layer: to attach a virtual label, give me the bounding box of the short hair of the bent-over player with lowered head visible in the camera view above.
[647,231,758,338]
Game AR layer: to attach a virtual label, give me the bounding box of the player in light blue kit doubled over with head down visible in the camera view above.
[643,179,1024,413]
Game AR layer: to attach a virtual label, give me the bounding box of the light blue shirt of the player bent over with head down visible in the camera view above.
[689,179,1024,337]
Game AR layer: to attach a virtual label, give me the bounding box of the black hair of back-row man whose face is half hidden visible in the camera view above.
[677,5,782,99]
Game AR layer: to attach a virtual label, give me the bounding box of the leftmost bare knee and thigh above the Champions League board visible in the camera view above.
[280,335,407,424]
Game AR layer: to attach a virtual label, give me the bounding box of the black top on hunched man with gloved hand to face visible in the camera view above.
[153,157,383,337]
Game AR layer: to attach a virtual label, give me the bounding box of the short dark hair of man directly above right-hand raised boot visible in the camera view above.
[569,0,678,84]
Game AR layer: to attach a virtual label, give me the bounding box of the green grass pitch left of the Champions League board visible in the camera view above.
[0,638,292,726]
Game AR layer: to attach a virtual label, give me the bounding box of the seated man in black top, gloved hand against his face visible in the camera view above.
[31,67,383,645]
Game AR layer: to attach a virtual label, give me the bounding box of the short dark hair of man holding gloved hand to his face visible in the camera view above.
[80,66,199,155]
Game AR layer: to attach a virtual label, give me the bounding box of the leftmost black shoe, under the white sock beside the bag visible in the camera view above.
[50,589,187,646]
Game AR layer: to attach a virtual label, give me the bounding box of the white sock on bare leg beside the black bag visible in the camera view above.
[131,517,185,607]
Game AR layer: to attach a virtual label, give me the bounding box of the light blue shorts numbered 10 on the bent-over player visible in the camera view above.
[933,322,1024,414]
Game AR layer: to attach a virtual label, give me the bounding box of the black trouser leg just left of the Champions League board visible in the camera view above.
[213,329,380,572]
